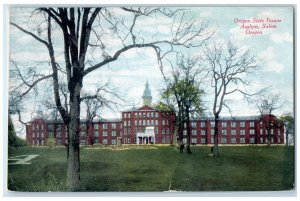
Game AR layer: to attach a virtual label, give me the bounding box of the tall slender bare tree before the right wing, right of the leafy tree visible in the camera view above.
[204,41,257,157]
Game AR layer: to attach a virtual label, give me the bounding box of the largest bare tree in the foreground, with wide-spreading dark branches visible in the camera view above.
[10,7,212,191]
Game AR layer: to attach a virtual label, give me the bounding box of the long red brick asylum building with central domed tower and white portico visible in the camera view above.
[26,82,284,146]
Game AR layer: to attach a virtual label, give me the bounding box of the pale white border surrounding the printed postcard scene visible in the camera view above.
[0,0,300,200]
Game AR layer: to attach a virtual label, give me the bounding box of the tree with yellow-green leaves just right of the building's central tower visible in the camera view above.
[162,54,204,154]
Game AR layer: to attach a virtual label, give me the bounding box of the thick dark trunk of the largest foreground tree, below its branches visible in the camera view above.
[67,82,81,191]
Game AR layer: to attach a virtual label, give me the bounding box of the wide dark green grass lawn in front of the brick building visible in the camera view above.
[8,146,295,192]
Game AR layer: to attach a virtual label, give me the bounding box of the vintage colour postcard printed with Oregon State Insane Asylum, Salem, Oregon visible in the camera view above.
[6,5,296,196]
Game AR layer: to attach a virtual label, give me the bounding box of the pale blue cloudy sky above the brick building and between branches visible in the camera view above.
[9,6,294,138]
